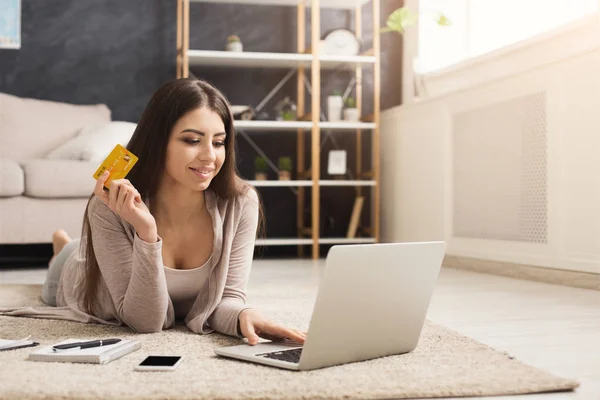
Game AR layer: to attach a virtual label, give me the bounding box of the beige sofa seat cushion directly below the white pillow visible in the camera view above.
[23,159,99,198]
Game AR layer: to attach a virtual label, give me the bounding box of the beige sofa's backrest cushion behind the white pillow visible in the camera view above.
[0,93,110,160]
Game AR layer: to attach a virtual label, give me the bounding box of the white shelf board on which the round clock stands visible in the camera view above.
[187,50,375,69]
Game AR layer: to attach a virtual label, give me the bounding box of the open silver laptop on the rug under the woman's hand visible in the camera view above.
[215,242,445,370]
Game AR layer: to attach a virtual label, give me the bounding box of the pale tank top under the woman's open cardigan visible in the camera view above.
[163,255,212,319]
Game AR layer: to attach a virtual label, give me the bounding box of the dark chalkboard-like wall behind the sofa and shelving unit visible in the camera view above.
[0,0,402,256]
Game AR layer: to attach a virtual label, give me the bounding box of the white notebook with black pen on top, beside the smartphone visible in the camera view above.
[29,339,142,364]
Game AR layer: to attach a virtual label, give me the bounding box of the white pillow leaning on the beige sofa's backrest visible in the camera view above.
[46,121,137,162]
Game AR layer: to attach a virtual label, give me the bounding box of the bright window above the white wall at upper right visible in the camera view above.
[415,0,599,73]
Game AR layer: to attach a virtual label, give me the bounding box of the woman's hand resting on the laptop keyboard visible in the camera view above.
[239,308,306,346]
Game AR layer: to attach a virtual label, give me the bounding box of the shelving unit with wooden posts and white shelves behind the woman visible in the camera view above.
[177,0,381,259]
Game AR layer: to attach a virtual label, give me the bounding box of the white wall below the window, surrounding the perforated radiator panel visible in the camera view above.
[381,14,600,273]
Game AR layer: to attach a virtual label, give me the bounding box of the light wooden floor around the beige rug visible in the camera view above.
[0,260,600,400]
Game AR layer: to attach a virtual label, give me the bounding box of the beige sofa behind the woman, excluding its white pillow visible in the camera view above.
[0,93,111,244]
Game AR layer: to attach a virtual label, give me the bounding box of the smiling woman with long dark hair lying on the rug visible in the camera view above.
[0,79,305,345]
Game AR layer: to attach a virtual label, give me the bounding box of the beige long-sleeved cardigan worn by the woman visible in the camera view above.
[0,188,258,336]
